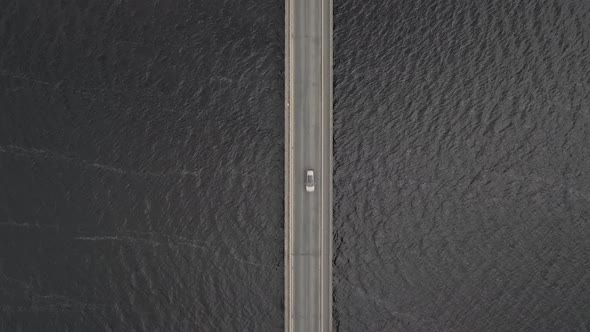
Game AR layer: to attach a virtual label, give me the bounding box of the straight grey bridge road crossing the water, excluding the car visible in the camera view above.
[285,0,332,332]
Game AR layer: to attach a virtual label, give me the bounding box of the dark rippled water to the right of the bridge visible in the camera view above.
[334,0,590,331]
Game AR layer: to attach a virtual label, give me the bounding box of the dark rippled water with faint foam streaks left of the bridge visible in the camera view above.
[0,0,284,331]
